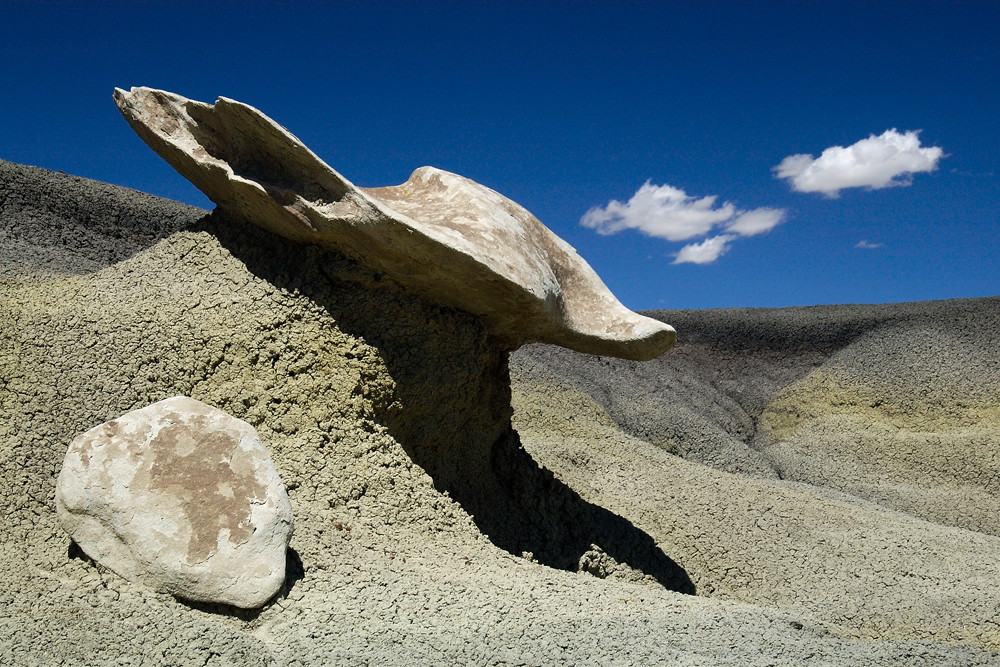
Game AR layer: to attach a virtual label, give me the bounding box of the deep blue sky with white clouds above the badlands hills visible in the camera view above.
[0,0,1000,310]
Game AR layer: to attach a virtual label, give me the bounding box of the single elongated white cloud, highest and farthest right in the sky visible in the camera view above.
[773,129,944,197]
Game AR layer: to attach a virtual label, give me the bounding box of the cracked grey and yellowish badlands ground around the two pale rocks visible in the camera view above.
[0,162,1000,665]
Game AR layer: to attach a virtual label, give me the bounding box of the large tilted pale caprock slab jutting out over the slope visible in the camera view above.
[114,88,675,360]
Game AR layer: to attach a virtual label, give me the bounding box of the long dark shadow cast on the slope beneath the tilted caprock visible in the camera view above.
[204,211,695,594]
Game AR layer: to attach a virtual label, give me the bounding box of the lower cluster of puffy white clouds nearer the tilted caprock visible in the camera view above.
[580,181,786,264]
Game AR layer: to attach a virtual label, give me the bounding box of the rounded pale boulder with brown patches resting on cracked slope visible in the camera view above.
[56,396,292,608]
